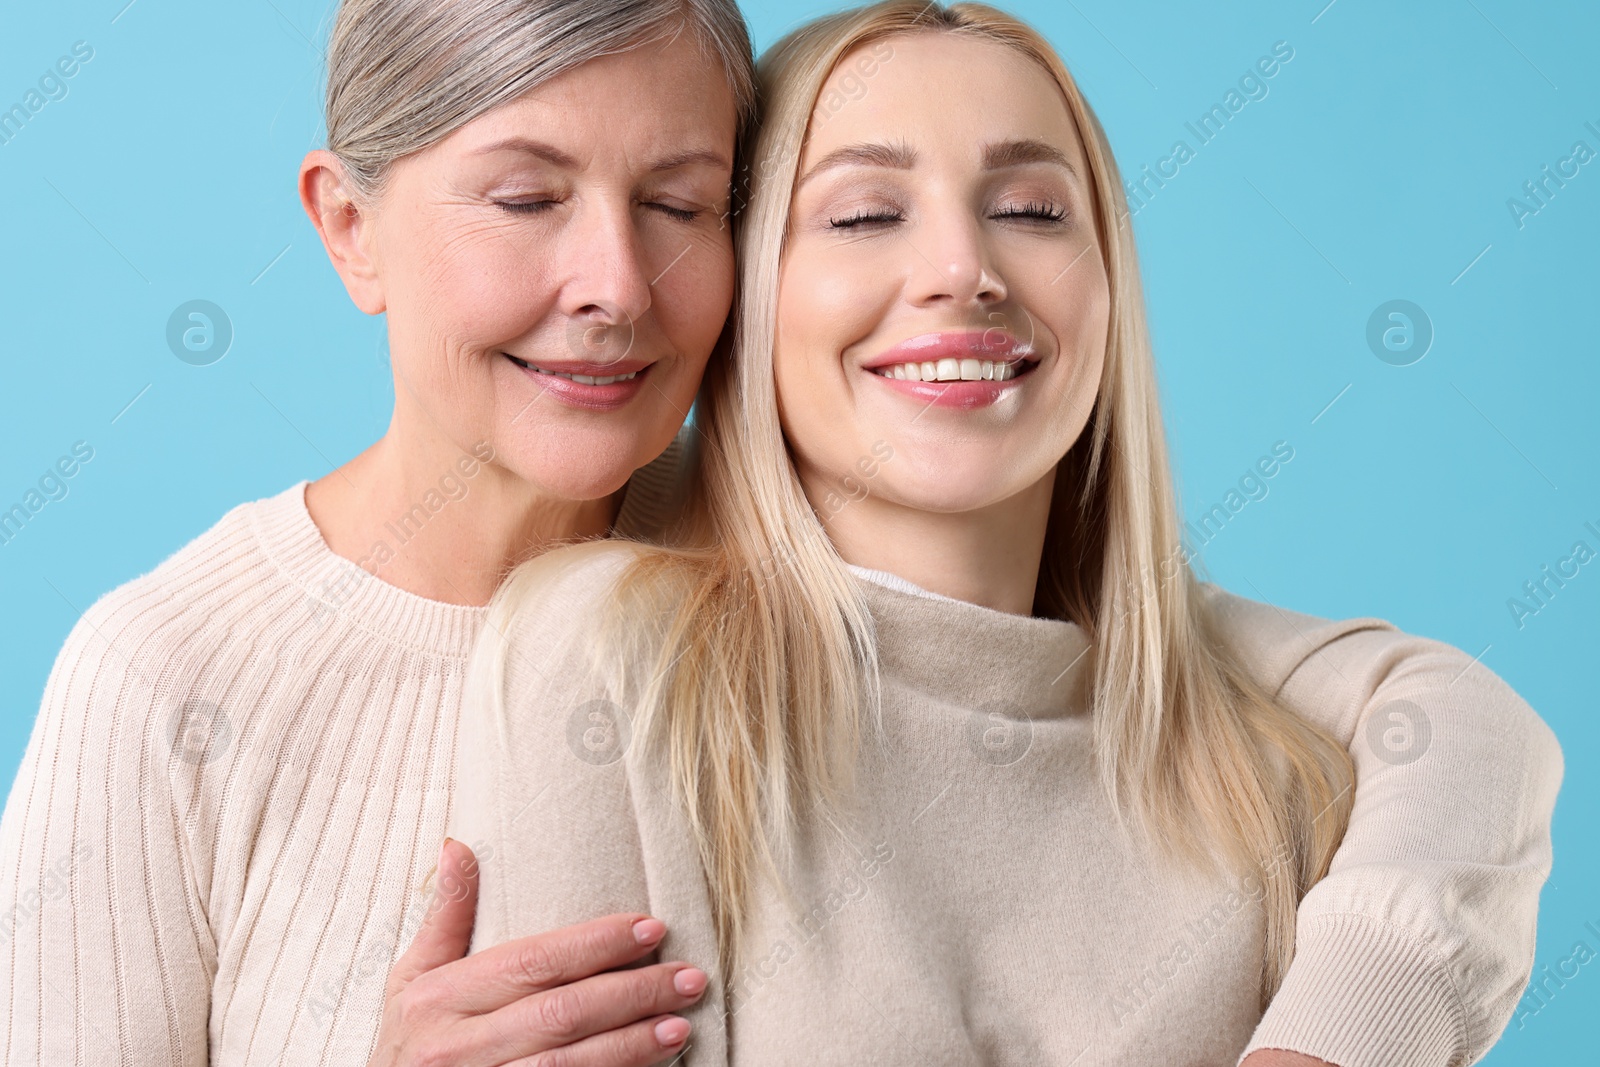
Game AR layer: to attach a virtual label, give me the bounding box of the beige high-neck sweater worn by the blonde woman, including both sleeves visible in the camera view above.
[450,544,1562,1067]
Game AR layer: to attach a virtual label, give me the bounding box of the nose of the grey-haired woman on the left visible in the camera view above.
[562,203,651,334]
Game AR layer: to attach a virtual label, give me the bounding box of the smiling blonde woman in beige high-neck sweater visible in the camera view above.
[451,0,1562,1067]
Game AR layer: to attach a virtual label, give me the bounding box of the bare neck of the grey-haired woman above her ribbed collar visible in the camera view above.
[306,414,622,606]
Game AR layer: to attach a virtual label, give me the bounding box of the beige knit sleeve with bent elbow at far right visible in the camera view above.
[1222,605,1563,1067]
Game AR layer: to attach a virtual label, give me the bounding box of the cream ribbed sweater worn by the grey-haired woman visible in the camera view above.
[0,446,680,1067]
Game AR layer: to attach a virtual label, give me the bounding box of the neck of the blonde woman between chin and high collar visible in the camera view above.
[802,470,1056,614]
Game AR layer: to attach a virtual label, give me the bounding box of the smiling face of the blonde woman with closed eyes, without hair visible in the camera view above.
[774,32,1110,512]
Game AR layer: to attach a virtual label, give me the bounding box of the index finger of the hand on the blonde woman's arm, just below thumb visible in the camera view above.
[450,912,667,1011]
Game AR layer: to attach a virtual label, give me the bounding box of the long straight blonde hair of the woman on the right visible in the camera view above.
[486,0,1354,1008]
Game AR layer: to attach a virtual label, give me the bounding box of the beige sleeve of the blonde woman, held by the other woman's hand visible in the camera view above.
[448,544,726,1067]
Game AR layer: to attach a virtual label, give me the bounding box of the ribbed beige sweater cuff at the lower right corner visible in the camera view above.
[1240,915,1469,1067]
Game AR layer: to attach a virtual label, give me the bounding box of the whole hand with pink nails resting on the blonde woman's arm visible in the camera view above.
[368,840,707,1067]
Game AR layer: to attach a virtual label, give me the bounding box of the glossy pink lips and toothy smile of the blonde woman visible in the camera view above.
[861,330,1038,410]
